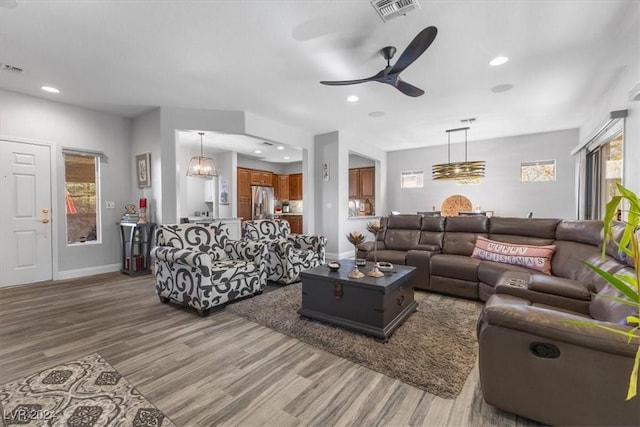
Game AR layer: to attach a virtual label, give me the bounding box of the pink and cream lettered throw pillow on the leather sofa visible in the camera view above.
[471,236,556,275]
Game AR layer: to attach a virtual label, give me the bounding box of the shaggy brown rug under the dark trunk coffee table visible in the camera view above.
[226,283,482,399]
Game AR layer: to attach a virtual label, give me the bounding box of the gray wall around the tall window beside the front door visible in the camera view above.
[0,90,134,279]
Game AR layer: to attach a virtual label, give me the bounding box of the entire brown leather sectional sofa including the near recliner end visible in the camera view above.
[359,215,640,425]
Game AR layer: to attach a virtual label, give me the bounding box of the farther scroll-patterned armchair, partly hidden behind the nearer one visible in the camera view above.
[242,219,327,285]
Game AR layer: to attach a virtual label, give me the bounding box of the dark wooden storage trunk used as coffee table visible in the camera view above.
[298,260,418,342]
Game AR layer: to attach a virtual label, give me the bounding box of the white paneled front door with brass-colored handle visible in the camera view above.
[0,140,53,286]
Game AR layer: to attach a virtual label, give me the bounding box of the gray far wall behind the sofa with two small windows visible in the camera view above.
[388,129,578,219]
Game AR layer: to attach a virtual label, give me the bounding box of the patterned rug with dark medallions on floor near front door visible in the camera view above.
[0,353,174,427]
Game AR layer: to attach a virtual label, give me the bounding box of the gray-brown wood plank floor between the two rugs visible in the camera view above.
[0,273,536,426]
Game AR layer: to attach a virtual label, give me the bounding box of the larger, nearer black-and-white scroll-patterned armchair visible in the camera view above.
[151,222,267,316]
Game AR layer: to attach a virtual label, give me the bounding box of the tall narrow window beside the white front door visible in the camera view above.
[63,152,101,244]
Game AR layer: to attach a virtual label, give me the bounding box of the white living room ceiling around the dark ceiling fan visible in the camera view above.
[0,0,640,155]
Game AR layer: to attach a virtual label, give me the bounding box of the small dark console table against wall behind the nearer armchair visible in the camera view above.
[119,222,156,276]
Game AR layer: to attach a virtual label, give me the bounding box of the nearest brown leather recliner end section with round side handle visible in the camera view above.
[478,276,640,425]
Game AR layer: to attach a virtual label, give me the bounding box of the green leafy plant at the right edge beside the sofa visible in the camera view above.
[568,184,640,400]
